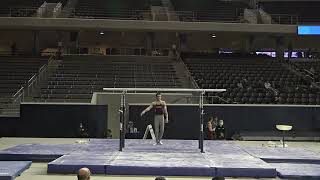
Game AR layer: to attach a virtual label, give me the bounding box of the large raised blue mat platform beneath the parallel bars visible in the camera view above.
[48,140,276,177]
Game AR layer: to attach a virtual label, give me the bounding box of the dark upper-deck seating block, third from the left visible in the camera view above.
[172,0,248,22]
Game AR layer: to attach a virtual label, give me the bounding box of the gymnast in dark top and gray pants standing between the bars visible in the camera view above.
[140,92,169,145]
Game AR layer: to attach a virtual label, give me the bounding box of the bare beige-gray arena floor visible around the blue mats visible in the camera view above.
[0,138,320,180]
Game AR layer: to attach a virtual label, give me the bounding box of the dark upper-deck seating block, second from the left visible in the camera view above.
[75,0,150,19]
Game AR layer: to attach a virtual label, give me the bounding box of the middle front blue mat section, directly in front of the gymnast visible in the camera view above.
[107,151,215,176]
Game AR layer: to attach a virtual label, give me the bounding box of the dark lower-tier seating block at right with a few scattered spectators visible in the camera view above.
[186,58,320,104]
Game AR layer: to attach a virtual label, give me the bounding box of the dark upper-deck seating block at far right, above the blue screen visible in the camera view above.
[259,1,320,24]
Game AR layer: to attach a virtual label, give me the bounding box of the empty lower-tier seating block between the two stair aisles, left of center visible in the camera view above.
[37,59,181,102]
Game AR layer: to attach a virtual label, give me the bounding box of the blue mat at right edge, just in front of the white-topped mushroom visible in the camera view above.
[242,147,320,164]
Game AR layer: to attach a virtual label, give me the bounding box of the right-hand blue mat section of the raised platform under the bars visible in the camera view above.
[204,141,277,178]
